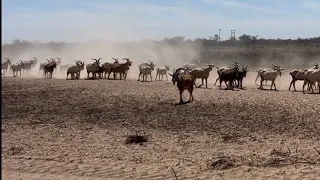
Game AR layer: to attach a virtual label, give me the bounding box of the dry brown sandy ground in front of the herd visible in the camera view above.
[1,77,320,179]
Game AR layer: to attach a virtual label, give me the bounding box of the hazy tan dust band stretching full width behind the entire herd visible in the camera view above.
[4,40,320,89]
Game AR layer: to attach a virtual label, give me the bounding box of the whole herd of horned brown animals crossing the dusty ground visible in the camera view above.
[2,57,320,101]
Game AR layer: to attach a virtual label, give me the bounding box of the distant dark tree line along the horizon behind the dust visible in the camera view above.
[2,34,320,63]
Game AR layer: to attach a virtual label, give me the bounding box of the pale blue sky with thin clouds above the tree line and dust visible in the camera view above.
[2,0,320,43]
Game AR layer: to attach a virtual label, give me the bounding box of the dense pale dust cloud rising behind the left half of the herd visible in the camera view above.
[4,41,200,79]
